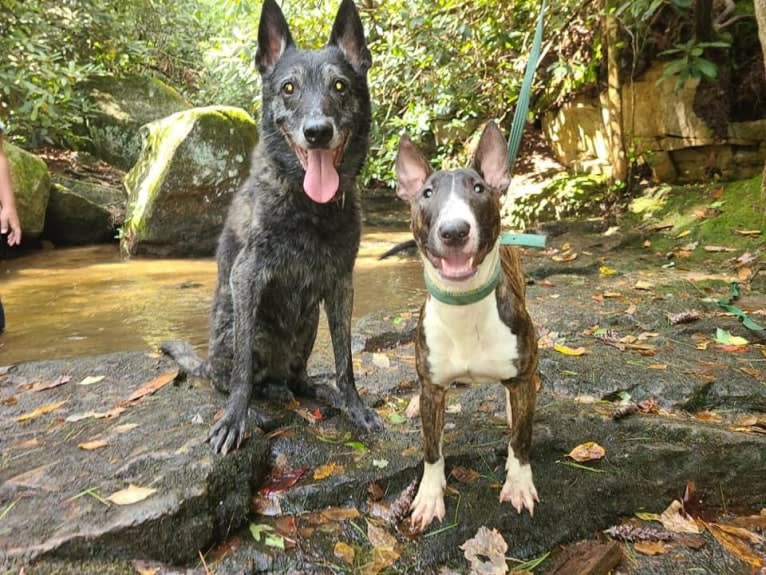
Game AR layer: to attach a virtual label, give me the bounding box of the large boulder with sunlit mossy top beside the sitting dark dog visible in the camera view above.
[122,106,258,256]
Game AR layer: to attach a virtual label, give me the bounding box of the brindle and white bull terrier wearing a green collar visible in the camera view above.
[396,123,537,529]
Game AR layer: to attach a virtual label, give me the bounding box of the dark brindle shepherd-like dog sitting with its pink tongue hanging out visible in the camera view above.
[162,0,383,453]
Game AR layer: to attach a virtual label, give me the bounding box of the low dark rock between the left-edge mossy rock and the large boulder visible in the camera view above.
[44,176,127,246]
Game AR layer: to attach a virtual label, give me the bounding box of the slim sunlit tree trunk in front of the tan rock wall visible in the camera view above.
[604,0,628,182]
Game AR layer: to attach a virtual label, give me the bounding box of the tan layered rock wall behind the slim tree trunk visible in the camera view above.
[543,64,766,182]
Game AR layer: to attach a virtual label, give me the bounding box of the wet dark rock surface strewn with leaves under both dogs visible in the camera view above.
[0,227,766,575]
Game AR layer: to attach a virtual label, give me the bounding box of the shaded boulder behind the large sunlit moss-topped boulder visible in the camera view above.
[86,76,191,170]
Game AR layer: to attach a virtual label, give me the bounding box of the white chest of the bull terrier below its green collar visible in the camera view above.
[423,294,519,385]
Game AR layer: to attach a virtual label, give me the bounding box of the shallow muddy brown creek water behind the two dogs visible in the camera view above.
[0,230,423,365]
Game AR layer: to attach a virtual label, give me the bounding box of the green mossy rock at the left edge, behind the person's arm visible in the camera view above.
[3,142,51,238]
